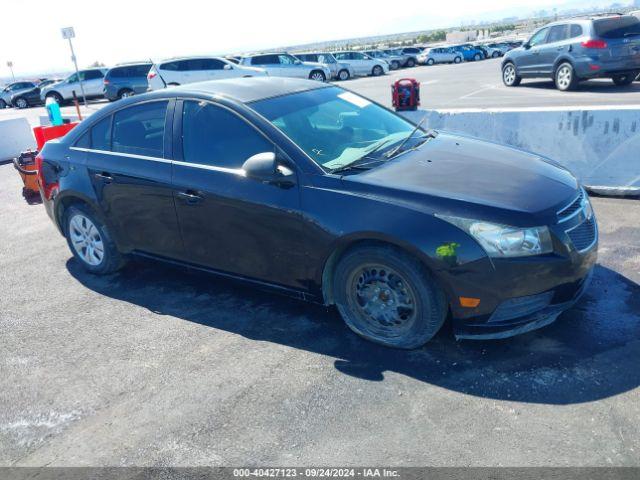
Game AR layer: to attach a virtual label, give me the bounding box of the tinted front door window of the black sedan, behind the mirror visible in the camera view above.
[182,101,274,169]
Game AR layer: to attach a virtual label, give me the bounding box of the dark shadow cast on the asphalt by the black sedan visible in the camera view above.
[67,259,640,404]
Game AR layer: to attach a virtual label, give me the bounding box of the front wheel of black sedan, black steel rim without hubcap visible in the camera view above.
[333,245,447,349]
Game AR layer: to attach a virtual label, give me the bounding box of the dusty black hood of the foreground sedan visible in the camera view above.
[345,133,578,218]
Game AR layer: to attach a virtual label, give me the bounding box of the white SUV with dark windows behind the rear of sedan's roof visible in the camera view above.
[147,57,267,90]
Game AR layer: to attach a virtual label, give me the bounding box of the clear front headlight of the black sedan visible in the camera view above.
[438,215,553,258]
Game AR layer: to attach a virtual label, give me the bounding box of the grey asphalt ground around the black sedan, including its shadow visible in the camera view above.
[0,165,640,466]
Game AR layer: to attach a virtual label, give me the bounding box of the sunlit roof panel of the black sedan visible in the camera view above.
[160,77,332,103]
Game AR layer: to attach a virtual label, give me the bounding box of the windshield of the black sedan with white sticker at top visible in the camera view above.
[251,87,415,170]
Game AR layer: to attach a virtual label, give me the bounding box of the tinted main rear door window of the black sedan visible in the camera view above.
[113,101,167,158]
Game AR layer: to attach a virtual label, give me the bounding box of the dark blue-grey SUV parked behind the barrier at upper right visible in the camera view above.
[502,15,640,91]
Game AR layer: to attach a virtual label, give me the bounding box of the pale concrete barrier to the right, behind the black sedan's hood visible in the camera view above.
[404,107,640,196]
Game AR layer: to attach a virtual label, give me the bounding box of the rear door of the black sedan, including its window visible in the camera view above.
[81,100,184,258]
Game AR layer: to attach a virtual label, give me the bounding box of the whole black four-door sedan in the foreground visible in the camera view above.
[33,78,597,348]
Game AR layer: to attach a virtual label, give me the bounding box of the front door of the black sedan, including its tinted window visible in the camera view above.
[173,100,305,287]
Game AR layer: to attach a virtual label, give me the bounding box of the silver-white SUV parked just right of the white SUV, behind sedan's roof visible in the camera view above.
[240,53,331,82]
